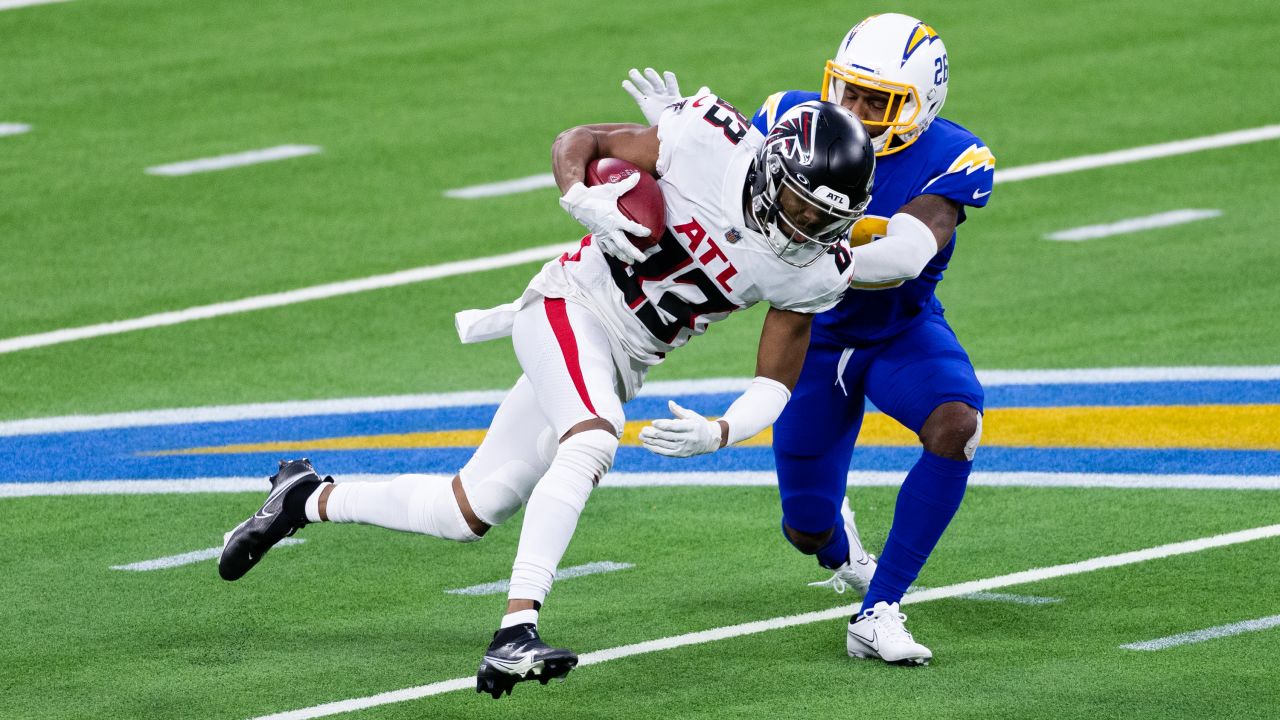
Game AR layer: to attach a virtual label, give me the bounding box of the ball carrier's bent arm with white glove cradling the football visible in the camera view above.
[552,124,658,263]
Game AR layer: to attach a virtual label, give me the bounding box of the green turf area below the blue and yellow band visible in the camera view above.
[0,488,1280,719]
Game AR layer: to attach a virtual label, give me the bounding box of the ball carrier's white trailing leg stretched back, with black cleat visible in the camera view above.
[219,378,556,580]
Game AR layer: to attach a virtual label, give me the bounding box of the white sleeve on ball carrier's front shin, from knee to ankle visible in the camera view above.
[507,430,618,602]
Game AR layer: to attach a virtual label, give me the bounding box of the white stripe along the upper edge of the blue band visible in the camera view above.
[0,365,1280,437]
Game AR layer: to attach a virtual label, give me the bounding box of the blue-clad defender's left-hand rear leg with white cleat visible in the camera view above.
[773,341,874,592]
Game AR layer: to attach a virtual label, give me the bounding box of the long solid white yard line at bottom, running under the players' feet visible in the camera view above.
[241,525,1280,720]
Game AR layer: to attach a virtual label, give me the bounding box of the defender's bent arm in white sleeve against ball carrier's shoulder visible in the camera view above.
[850,195,960,287]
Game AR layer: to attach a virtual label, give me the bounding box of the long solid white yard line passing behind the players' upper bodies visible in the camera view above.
[10,126,1280,355]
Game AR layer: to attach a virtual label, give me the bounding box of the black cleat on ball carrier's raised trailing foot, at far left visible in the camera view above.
[218,459,333,580]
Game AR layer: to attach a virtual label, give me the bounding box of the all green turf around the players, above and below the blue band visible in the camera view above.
[0,0,1280,719]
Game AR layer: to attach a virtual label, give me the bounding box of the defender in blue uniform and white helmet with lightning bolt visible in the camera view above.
[622,13,996,665]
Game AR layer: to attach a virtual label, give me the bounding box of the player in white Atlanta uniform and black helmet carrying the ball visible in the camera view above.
[219,94,874,698]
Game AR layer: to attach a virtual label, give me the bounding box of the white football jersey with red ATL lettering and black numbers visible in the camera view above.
[460,88,852,392]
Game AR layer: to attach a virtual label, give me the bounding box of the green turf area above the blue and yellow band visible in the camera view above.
[0,1,1280,418]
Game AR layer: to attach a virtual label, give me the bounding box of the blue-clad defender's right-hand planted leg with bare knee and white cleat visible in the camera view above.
[850,314,983,664]
